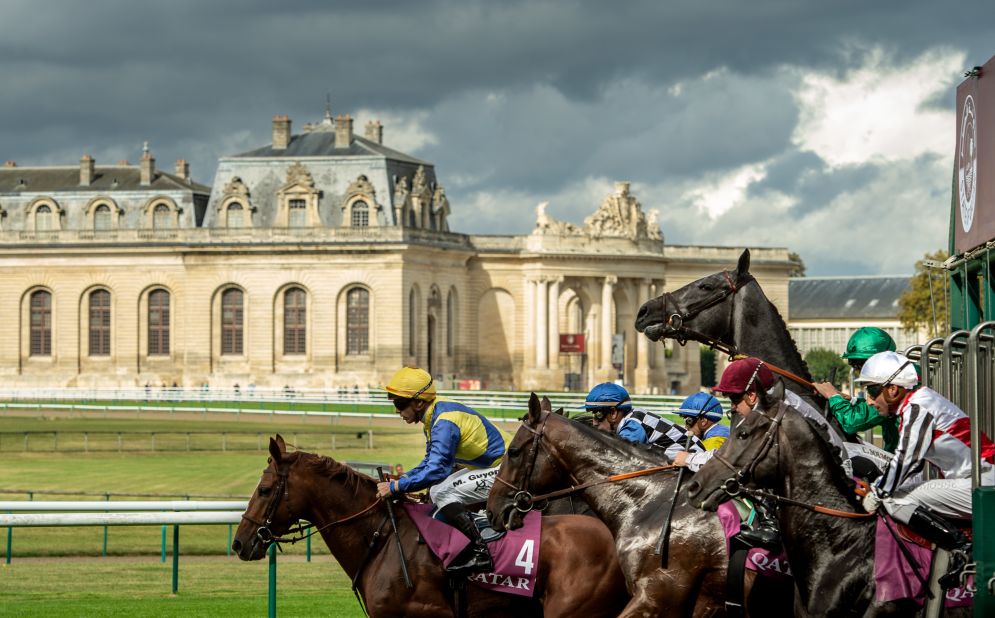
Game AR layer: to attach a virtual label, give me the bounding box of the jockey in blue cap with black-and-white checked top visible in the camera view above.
[581,382,705,461]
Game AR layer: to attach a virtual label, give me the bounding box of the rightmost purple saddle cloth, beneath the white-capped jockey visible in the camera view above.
[874,517,974,607]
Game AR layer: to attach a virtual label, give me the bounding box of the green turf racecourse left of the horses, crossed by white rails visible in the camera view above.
[0,406,436,617]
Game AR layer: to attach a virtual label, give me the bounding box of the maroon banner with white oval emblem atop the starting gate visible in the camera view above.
[953,57,995,253]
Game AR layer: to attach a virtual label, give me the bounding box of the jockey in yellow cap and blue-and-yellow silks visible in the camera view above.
[377,367,507,573]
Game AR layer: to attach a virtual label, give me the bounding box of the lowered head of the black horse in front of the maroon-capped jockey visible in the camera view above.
[687,381,788,511]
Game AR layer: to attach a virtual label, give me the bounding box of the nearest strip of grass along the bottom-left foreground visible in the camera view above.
[0,555,363,618]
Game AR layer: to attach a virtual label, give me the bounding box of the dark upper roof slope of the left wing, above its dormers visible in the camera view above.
[0,165,211,194]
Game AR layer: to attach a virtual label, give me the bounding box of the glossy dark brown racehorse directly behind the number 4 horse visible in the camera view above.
[487,393,790,617]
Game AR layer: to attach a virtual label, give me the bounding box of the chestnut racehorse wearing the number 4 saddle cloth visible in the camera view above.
[232,435,628,618]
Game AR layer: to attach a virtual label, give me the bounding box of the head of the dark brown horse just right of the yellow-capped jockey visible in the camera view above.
[487,393,570,530]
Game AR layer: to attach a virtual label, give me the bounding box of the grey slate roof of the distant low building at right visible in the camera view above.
[788,276,912,320]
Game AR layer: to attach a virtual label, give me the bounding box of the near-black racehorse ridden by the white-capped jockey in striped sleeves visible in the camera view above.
[687,385,970,616]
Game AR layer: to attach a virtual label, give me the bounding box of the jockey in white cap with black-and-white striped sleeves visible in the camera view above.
[857,351,995,588]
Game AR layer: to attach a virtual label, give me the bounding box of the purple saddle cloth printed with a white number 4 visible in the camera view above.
[404,503,542,597]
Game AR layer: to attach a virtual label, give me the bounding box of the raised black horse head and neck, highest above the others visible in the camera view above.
[635,249,824,409]
